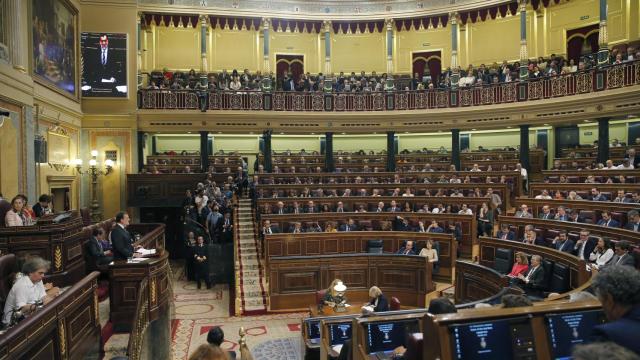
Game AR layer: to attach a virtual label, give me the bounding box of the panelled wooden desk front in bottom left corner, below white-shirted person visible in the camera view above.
[0,272,100,360]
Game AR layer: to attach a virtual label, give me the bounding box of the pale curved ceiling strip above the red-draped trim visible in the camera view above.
[138,0,513,20]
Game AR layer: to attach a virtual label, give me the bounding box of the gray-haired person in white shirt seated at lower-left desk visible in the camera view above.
[2,256,60,326]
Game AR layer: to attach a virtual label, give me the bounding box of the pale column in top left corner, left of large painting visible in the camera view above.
[3,0,28,72]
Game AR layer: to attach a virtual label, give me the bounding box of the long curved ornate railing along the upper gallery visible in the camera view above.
[138,61,640,111]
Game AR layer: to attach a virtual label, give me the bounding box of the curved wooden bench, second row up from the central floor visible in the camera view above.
[264,231,457,283]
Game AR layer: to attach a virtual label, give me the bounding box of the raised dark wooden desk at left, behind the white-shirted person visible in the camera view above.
[0,210,86,286]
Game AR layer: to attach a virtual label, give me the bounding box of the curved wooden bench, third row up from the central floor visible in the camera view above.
[262,212,476,258]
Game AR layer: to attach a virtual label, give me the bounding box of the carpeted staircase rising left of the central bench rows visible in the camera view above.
[235,199,267,316]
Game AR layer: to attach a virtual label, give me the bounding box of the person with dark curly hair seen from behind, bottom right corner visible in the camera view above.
[591,265,640,355]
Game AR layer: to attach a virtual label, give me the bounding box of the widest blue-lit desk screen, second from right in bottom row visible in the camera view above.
[449,317,536,360]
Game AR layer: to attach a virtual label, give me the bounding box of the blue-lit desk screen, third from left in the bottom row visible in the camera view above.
[365,319,420,354]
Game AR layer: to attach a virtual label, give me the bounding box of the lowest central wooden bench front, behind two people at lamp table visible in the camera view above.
[268,254,435,310]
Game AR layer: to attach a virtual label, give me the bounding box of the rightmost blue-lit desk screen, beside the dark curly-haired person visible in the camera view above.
[545,310,605,359]
